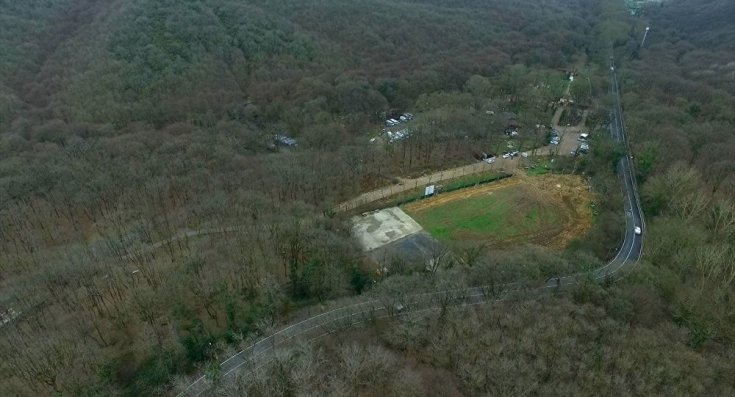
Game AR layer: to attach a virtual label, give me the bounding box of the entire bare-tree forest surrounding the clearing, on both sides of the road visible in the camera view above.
[0,0,735,395]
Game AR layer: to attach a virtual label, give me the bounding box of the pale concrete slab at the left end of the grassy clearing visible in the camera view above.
[352,207,422,251]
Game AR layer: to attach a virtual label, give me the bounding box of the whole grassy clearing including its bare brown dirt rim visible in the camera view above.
[403,174,593,248]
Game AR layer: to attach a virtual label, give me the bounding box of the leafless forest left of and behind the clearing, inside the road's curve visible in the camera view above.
[0,0,605,395]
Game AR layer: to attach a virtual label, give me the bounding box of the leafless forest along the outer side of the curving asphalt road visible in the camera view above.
[221,0,735,395]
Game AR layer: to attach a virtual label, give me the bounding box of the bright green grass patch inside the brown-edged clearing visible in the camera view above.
[404,187,558,241]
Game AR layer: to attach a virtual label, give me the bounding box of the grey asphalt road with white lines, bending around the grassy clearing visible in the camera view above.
[178,58,646,396]
